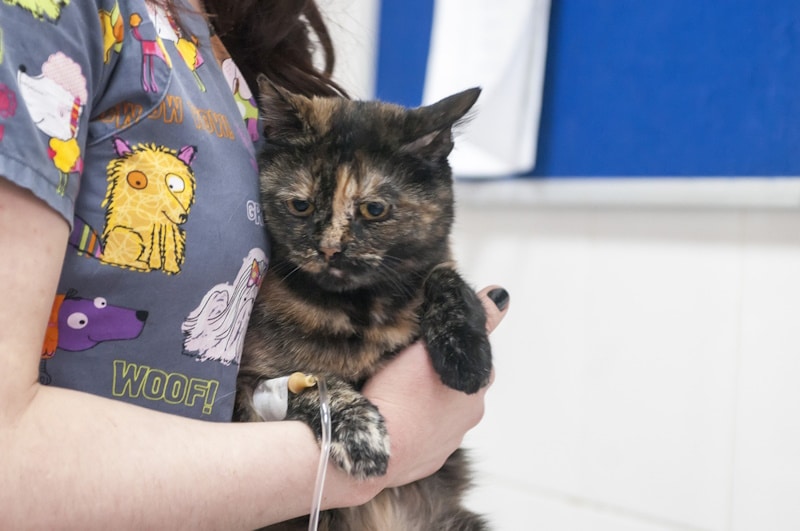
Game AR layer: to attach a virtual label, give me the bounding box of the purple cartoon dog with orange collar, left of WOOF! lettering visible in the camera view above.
[39,290,148,384]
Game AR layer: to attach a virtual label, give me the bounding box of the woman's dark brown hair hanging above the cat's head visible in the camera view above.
[205,0,344,96]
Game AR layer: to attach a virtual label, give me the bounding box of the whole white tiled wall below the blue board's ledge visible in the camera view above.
[454,193,800,531]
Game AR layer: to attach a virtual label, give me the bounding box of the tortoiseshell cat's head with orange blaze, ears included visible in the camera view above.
[259,78,480,291]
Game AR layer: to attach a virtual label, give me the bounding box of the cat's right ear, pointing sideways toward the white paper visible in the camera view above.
[401,87,481,159]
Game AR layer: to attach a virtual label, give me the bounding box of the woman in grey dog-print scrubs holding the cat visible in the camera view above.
[0,0,507,529]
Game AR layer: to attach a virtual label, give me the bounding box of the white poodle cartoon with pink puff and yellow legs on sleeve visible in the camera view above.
[17,52,88,195]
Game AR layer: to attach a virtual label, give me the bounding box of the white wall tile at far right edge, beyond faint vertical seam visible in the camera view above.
[732,213,800,531]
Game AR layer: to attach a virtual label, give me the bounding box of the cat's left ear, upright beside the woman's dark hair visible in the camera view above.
[257,74,318,144]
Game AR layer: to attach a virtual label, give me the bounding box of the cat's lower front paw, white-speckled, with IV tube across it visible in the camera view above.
[286,377,389,479]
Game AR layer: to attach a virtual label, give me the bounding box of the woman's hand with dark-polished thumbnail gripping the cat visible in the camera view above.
[363,286,509,487]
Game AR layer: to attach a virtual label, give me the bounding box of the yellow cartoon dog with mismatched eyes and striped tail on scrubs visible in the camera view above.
[69,137,197,275]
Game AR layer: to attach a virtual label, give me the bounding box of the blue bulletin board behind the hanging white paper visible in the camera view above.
[376,0,800,179]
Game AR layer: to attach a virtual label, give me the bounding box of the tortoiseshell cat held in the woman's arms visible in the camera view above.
[236,78,491,531]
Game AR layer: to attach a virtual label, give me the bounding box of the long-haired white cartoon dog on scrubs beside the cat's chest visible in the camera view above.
[181,249,267,365]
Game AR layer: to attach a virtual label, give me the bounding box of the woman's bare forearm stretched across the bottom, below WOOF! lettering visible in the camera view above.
[0,387,377,529]
